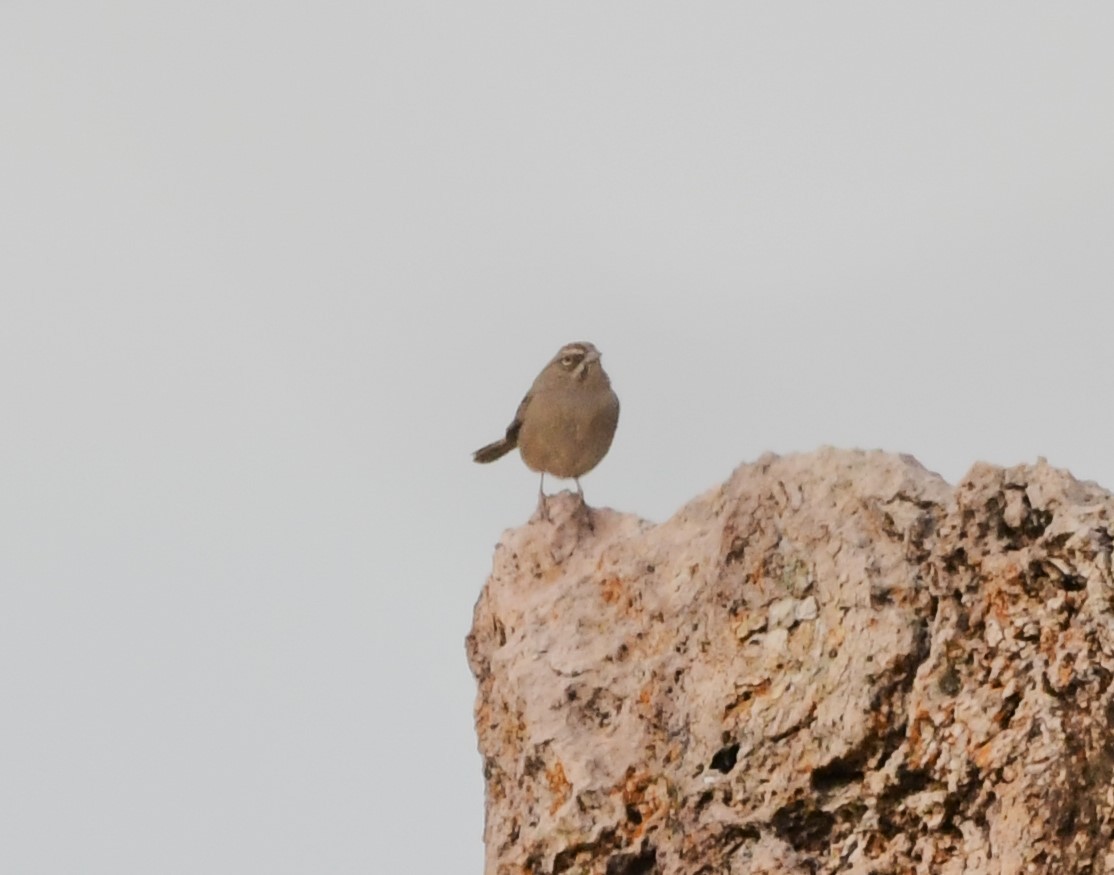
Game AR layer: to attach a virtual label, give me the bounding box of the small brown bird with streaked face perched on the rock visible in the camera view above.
[472,341,619,518]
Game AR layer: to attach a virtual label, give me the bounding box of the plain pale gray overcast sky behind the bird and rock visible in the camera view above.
[0,0,1114,875]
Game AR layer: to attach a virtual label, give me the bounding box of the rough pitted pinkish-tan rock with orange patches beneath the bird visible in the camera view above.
[468,449,1114,875]
